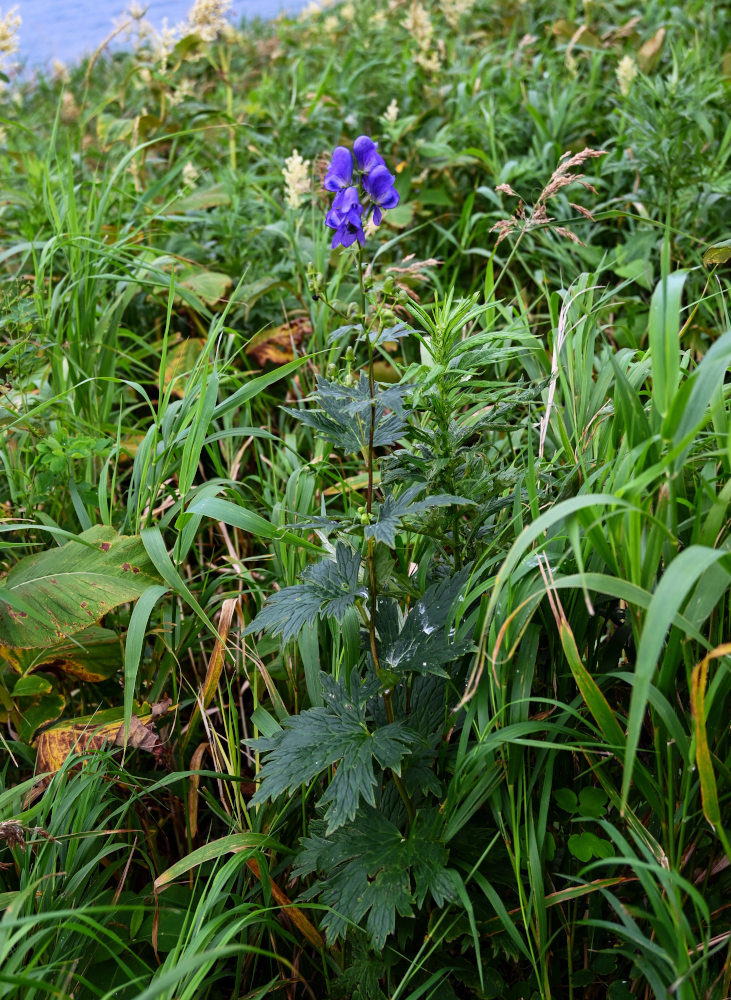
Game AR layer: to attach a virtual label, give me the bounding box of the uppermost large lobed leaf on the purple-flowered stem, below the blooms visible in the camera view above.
[285,375,407,454]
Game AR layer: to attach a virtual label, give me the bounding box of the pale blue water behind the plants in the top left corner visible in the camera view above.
[17,0,305,68]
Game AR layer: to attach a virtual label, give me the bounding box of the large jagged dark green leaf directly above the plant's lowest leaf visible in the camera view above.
[248,671,413,833]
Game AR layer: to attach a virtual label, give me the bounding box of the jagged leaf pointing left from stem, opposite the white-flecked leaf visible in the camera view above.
[244,542,368,642]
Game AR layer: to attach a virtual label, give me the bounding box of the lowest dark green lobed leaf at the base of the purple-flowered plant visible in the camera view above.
[294,807,454,950]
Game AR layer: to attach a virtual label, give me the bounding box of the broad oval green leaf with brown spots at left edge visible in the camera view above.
[0,525,162,649]
